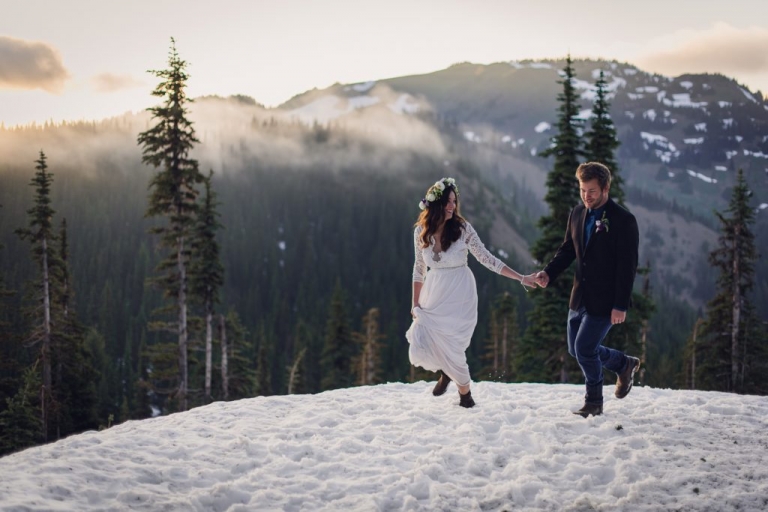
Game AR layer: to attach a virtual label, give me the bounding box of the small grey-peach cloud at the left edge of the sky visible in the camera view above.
[0,36,69,93]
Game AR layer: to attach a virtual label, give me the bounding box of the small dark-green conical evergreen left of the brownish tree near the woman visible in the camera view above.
[320,281,355,391]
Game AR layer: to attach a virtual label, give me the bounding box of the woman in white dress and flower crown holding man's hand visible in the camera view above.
[405,178,534,407]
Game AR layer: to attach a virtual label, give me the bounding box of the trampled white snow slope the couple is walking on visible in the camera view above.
[0,382,768,511]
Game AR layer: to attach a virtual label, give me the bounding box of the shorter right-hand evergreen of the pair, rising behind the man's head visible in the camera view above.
[585,70,624,206]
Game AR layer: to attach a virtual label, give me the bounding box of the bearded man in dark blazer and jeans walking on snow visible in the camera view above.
[536,162,640,418]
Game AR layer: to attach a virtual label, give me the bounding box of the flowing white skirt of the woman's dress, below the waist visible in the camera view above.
[405,265,477,386]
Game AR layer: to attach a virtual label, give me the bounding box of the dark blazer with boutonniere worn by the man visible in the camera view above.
[544,198,639,316]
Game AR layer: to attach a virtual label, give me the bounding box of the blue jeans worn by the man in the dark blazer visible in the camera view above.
[568,307,626,405]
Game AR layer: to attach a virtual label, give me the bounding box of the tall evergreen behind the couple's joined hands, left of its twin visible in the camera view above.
[516,55,583,382]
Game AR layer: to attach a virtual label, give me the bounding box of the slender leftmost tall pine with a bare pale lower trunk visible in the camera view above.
[16,150,56,442]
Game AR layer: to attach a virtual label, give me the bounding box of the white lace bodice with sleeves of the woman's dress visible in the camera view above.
[413,222,504,282]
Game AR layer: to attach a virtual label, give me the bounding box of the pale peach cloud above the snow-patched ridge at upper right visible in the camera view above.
[638,23,768,75]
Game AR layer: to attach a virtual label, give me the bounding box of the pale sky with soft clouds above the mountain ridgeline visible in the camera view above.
[0,0,768,126]
